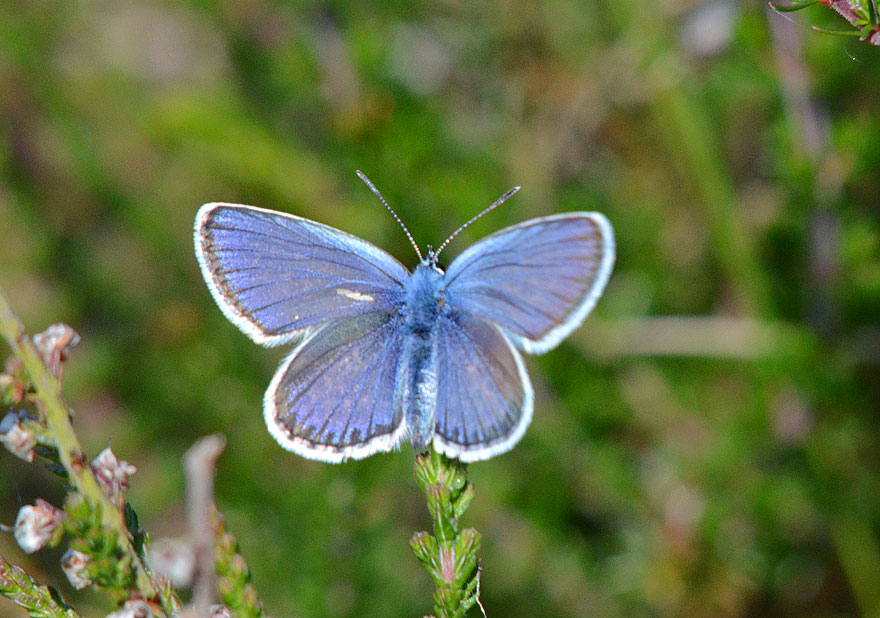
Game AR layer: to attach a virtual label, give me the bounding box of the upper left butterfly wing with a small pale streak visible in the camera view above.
[194,203,409,346]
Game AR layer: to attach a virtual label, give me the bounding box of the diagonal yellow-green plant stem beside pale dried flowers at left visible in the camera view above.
[0,288,175,615]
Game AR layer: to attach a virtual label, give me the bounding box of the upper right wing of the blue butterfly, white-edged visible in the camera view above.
[445,212,614,354]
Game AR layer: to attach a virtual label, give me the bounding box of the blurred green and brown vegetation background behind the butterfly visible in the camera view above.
[0,0,880,618]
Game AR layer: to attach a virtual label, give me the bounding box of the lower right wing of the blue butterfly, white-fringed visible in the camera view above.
[434,312,534,462]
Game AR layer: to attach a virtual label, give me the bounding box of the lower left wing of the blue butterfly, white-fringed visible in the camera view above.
[263,311,405,463]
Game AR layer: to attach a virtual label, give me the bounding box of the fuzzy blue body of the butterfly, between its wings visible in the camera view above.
[399,260,445,452]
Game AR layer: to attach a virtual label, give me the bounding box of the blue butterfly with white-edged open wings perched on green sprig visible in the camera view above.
[194,171,614,463]
